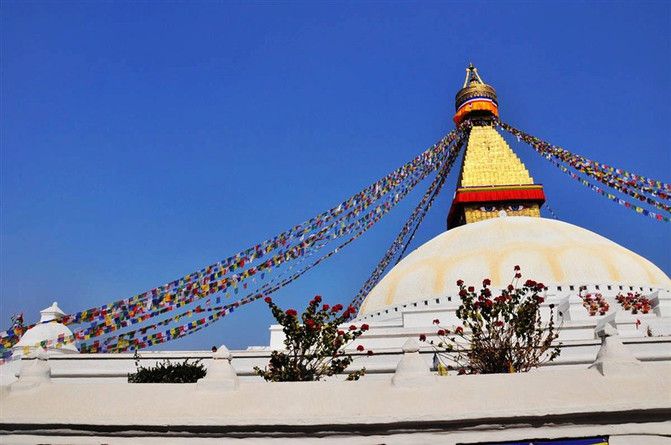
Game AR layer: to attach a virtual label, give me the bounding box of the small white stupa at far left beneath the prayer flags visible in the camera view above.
[12,301,79,357]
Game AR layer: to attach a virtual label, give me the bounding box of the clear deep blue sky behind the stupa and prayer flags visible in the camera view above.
[0,0,671,349]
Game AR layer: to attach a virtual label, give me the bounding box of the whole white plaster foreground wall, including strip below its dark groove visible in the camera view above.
[0,363,671,444]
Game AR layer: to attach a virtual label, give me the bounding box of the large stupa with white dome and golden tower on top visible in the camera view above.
[359,64,671,332]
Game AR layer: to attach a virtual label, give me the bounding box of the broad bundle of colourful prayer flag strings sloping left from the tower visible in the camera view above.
[0,127,468,357]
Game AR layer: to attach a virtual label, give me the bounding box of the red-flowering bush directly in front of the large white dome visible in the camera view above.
[426,266,560,374]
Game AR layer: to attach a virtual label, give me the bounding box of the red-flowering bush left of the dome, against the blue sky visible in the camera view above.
[254,295,372,382]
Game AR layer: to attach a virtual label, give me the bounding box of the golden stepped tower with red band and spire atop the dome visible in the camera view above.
[447,64,545,229]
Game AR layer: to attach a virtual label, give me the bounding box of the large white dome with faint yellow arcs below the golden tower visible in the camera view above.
[359,216,671,316]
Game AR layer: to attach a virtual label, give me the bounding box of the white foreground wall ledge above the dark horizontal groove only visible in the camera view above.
[0,364,671,426]
